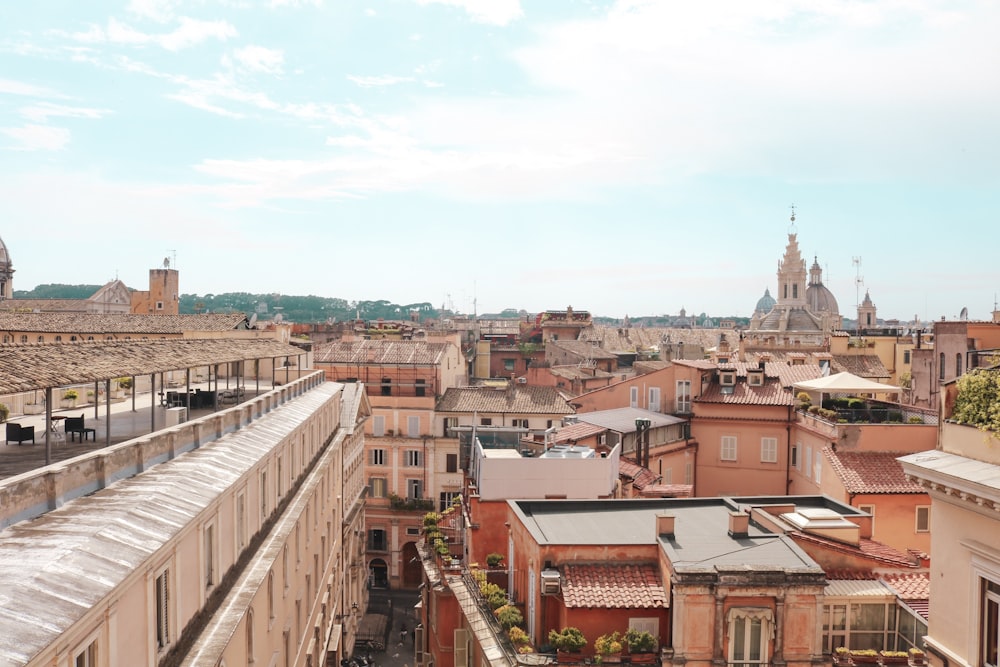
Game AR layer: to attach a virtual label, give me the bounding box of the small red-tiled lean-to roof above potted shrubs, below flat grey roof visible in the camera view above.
[562,564,668,609]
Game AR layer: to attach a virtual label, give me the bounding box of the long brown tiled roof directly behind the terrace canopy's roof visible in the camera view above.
[0,312,246,336]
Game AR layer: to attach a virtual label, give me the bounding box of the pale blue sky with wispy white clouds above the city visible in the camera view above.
[0,0,1000,321]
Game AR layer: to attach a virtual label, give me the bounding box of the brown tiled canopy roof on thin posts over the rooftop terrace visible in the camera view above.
[0,338,303,394]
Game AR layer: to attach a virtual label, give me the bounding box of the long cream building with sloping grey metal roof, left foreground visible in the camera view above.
[0,373,369,667]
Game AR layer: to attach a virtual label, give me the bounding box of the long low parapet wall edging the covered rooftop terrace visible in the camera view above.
[0,372,325,529]
